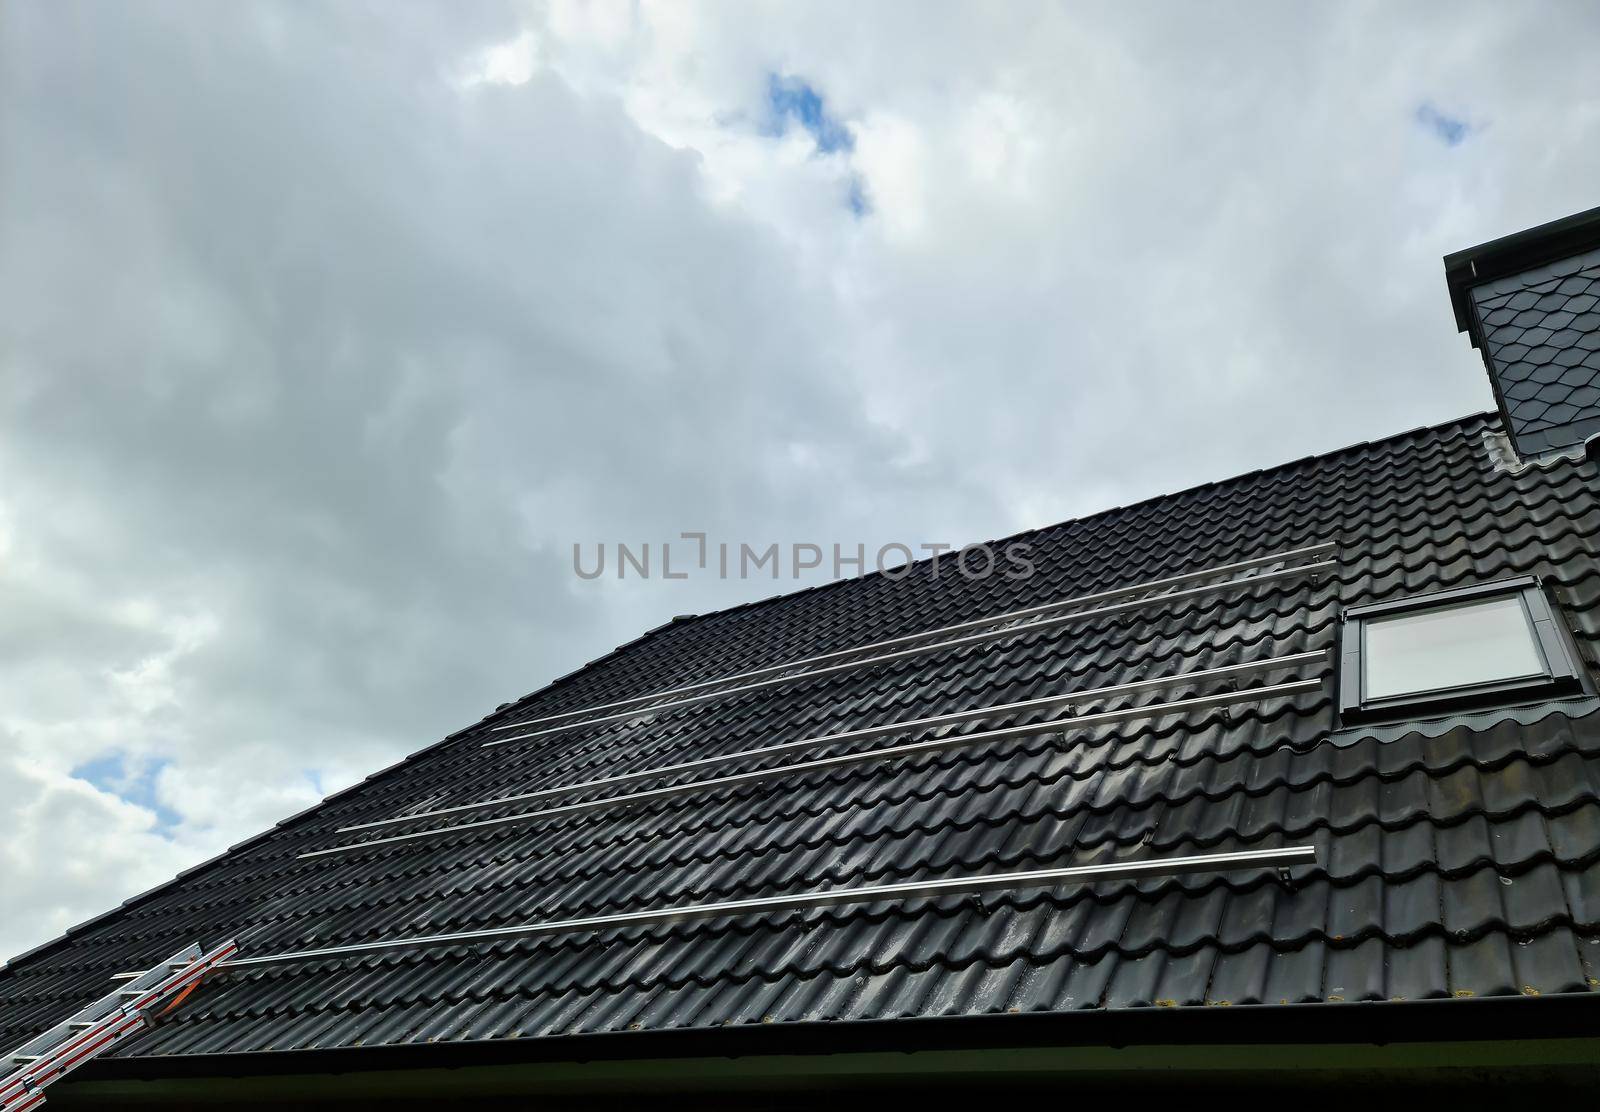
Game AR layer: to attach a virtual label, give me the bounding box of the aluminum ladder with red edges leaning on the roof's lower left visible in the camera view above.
[0,941,238,1112]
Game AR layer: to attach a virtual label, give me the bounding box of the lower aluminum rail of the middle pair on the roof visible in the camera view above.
[296,680,1322,861]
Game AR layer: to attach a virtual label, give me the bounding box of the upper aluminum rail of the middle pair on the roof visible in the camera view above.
[347,650,1328,834]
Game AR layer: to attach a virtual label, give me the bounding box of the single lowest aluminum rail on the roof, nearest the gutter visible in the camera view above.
[236,845,1317,970]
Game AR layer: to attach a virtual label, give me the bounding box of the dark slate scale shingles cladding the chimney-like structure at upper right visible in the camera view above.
[1472,250,1600,456]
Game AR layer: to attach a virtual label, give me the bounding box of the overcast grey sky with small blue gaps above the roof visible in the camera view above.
[0,0,1600,957]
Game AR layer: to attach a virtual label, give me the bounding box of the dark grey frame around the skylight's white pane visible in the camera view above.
[1339,576,1582,723]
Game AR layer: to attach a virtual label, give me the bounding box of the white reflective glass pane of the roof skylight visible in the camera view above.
[1363,597,1546,699]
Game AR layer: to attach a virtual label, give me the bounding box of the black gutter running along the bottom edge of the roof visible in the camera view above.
[77,992,1600,1082]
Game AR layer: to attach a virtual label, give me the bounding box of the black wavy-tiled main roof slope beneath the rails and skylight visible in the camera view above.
[0,418,1600,1054]
